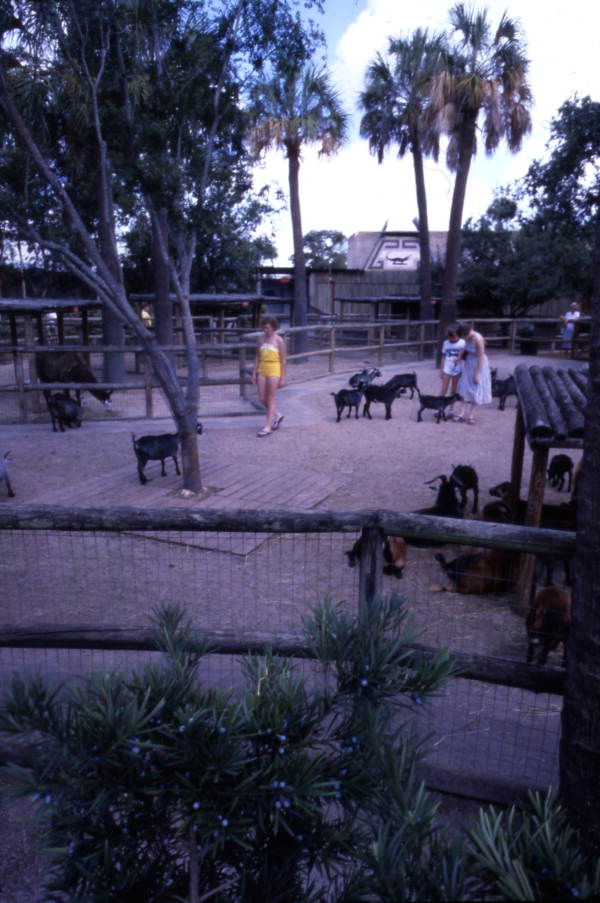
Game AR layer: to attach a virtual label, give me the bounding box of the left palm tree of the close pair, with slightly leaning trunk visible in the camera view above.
[359,28,442,320]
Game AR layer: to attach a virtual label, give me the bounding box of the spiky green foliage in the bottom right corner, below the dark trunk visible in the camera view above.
[470,790,600,900]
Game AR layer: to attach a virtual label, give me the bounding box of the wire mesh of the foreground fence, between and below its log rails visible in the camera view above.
[0,509,567,800]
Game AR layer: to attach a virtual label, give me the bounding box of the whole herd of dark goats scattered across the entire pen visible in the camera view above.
[0,351,578,665]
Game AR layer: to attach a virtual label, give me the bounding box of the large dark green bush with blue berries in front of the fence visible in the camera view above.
[0,597,453,903]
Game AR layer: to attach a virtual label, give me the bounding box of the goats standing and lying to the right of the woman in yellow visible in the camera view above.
[331,367,578,665]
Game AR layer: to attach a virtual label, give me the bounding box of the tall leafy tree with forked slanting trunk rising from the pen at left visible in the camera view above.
[0,0,324,490]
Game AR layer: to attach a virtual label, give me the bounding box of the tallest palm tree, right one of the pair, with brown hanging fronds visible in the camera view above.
[427,3,532,336]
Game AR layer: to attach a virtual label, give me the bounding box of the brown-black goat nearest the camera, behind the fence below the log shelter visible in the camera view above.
[526,586,571,666]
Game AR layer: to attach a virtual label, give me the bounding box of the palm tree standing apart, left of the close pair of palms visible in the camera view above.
[249,64,348,354]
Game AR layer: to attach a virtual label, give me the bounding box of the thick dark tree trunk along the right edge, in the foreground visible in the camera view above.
[560,208,600,855]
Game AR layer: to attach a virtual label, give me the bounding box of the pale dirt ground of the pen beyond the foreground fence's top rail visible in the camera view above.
[0,353,580,903]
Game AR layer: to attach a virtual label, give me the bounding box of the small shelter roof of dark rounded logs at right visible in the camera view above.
[514,364,587,449]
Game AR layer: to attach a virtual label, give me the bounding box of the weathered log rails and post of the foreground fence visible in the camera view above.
[0,505,575,693]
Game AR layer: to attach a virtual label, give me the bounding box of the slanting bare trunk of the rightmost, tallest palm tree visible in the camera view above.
[438,116,476,348]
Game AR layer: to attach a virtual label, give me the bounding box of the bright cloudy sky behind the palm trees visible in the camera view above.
[255,0,600,266]
